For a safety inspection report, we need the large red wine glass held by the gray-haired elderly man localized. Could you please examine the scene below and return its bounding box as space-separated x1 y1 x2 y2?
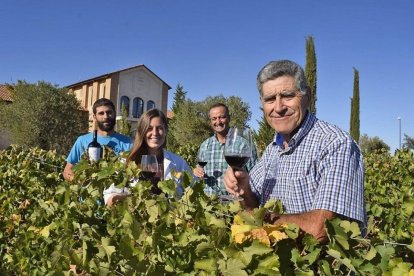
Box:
222 127 252 201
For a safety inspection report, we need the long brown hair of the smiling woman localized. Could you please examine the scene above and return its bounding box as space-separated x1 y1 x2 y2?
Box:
127 108 168 163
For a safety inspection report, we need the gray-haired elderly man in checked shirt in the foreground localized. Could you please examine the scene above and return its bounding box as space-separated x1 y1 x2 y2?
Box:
224 60 366 239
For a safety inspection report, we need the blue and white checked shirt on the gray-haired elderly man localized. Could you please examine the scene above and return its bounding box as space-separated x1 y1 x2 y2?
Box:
250 112 366 226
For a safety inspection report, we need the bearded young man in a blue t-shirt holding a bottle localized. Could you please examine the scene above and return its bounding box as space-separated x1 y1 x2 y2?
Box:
63 98 132 181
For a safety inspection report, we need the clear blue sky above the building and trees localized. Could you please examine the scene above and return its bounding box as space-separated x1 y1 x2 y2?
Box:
0 0 414 150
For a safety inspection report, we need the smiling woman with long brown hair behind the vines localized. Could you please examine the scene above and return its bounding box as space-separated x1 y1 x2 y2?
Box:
103 109 191 206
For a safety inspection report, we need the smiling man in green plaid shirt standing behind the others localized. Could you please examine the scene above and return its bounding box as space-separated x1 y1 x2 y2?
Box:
193 103 257 196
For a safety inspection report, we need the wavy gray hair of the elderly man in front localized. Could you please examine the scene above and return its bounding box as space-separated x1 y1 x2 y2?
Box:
257 60 308 95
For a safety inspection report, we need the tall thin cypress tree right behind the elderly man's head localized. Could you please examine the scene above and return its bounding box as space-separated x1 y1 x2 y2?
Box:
305 36 317 114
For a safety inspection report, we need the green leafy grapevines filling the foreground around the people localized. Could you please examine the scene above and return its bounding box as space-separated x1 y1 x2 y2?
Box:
0 146 414 276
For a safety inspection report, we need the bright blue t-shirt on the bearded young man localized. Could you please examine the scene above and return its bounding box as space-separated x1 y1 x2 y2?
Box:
66 132 132 165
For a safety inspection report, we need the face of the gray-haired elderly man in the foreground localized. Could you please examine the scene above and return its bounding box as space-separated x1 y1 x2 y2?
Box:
261 76 309 141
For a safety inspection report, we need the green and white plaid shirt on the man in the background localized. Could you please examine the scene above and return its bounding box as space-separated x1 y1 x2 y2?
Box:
200 135 257 195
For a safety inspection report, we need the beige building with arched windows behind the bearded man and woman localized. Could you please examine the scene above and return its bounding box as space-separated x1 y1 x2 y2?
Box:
66 65 171 134
